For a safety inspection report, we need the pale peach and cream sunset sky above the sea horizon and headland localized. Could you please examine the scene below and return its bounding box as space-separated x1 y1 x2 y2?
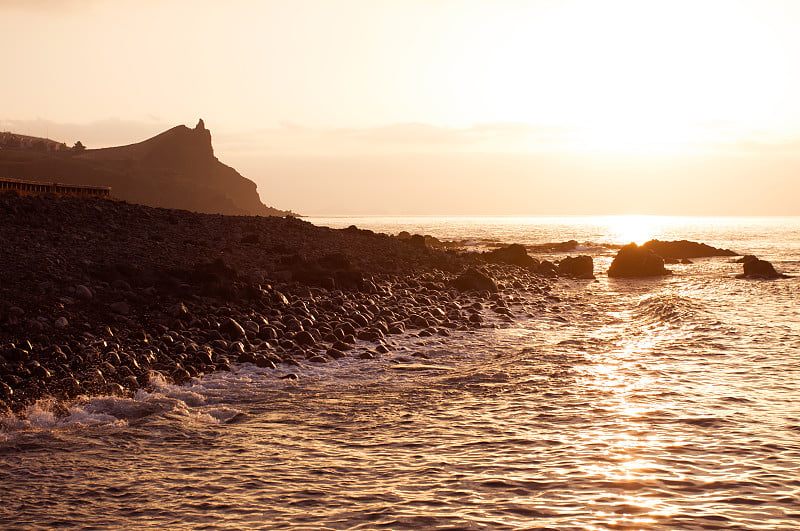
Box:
0 0 800 215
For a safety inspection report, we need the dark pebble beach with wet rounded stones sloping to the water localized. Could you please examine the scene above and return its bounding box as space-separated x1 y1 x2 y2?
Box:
0 195 564 416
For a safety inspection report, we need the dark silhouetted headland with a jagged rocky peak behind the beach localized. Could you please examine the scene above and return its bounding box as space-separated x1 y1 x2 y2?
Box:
0 120 292 216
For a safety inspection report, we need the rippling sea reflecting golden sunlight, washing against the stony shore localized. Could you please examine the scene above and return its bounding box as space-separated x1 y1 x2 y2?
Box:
0 216 800 530
